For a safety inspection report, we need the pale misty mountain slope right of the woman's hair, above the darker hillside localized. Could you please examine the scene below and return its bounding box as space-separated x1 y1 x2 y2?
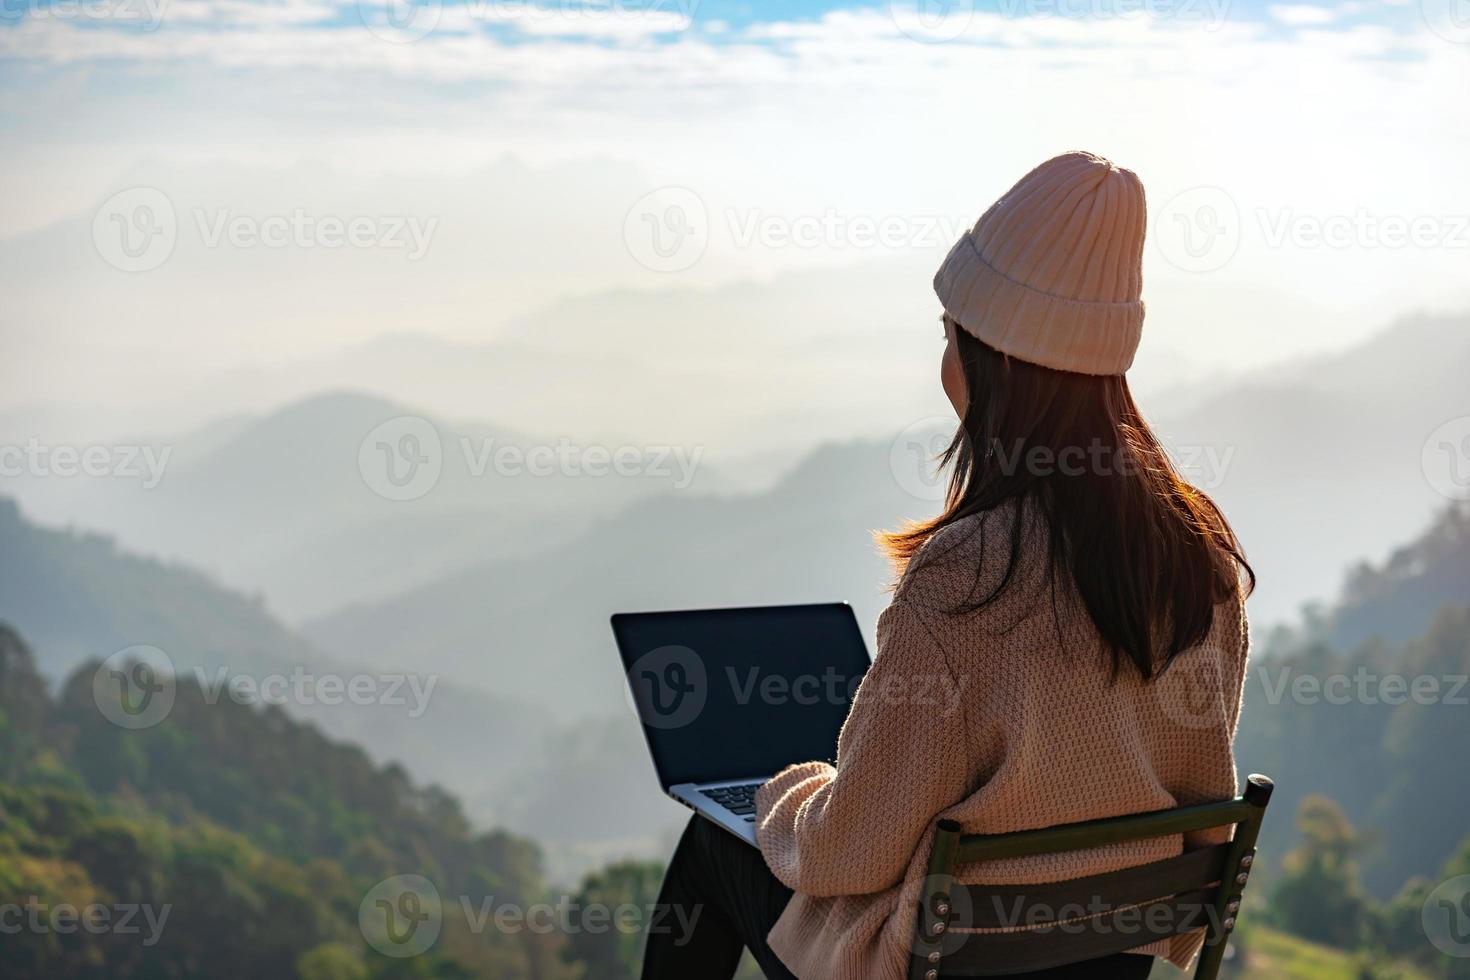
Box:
1145 316 1470 624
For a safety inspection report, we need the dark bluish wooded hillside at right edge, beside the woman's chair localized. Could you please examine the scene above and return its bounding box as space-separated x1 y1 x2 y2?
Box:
1236 504 1470 896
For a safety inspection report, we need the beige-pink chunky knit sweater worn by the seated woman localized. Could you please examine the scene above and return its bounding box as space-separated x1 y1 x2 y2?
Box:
756 505 1247 980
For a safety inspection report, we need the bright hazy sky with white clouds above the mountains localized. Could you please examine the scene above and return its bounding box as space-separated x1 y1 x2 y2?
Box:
0 0 1470 437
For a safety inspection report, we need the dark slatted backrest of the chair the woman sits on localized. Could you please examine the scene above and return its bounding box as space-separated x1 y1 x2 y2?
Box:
908 776 1273 980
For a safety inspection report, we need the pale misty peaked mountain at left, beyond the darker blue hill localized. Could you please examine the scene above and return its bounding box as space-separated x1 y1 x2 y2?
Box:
6 392 711 617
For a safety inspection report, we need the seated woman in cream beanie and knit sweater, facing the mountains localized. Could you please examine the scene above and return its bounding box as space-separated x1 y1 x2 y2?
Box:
644 153 1254 980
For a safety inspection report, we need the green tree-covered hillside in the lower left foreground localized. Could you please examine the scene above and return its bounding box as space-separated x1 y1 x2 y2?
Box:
0 626 616 980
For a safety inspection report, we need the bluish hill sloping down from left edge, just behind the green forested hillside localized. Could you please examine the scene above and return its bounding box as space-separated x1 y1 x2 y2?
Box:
0 498 542 820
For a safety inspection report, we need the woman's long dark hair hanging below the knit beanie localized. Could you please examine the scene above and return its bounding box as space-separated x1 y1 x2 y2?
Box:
881 319 1255 679
